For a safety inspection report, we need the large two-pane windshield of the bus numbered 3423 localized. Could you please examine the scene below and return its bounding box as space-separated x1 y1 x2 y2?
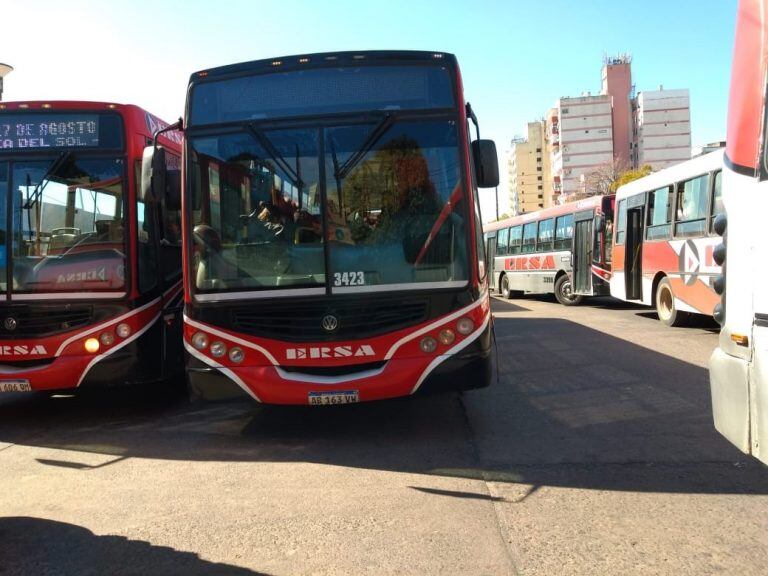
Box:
190 115 469 293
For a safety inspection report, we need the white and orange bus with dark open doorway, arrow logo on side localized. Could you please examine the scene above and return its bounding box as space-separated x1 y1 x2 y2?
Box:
611 150 723 326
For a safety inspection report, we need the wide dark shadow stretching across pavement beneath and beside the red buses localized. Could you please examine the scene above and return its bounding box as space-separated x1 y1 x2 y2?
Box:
0 304 768 497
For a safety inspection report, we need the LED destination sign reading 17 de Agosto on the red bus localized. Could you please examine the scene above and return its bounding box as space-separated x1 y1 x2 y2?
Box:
0 113 101 151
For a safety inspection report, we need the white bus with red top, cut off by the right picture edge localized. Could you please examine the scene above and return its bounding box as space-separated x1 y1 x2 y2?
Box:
709 0 768 463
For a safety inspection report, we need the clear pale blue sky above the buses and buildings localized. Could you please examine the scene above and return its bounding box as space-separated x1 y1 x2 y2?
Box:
0 0 736 220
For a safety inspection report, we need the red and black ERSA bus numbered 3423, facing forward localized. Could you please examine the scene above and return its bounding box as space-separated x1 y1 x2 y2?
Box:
146 52 498 404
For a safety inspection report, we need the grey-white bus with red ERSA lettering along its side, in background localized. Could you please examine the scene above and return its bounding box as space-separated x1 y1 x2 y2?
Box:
485 195 614 306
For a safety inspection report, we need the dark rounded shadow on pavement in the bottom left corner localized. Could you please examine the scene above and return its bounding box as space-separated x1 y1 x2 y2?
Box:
0 517 259 576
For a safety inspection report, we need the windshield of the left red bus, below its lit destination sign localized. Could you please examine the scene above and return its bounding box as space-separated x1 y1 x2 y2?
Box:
0 153 125 294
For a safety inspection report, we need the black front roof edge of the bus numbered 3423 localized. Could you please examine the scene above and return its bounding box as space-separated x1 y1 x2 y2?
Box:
190 50 456 82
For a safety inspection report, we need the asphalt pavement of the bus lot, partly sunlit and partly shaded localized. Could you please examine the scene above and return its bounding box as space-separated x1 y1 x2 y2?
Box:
0 297 768 576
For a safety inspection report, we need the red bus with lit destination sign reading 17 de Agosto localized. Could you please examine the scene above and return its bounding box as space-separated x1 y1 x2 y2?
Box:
0 102 183 391
